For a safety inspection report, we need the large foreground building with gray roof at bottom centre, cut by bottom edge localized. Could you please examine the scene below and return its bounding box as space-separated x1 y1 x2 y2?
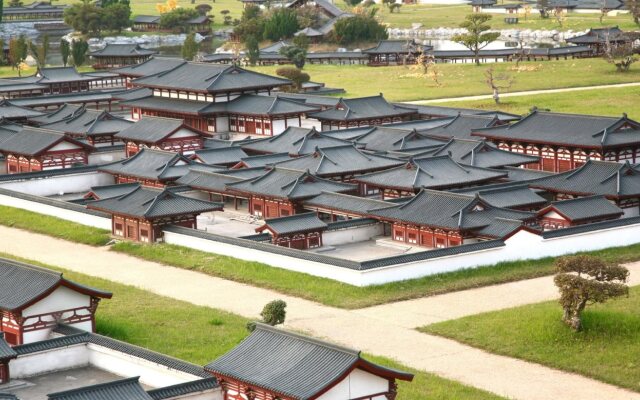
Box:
204 323 413 400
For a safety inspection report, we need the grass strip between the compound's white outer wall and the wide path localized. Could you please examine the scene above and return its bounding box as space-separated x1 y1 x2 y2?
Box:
6 207 640 309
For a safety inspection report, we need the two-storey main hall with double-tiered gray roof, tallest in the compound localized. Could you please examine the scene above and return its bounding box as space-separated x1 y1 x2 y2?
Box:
121 61 319 136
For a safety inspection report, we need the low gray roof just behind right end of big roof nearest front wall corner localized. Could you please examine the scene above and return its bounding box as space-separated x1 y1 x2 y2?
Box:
455 185 547 208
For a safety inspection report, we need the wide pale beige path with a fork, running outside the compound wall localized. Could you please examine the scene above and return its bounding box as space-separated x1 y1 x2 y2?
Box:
0 227 640 400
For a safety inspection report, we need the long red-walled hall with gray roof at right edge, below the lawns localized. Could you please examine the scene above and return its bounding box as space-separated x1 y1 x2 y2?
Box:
473 111 640 172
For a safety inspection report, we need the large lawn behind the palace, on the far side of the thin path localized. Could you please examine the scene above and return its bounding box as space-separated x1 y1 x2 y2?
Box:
249 58 640 101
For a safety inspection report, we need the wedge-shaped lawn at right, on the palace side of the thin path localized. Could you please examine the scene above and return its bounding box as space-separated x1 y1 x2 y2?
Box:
440 86 640 115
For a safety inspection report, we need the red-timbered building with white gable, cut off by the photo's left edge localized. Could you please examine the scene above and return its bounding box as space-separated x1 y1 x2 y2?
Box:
0 259 111 346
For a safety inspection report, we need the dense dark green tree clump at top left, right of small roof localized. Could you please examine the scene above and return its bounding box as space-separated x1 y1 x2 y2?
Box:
64 0 131 35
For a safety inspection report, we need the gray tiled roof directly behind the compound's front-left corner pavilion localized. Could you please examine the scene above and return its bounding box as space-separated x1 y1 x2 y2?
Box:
99 148 193 181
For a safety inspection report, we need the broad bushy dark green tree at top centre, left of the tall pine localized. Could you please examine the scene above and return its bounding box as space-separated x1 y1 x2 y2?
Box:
332 7 389 45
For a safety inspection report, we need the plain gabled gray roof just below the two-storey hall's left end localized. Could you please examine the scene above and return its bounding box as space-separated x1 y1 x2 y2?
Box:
114 116 204 143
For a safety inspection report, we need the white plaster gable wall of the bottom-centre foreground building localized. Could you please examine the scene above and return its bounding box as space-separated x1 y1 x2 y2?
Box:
318 369 389 400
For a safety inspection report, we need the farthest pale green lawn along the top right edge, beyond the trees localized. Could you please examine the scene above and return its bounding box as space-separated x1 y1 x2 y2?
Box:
356 2 637 31
